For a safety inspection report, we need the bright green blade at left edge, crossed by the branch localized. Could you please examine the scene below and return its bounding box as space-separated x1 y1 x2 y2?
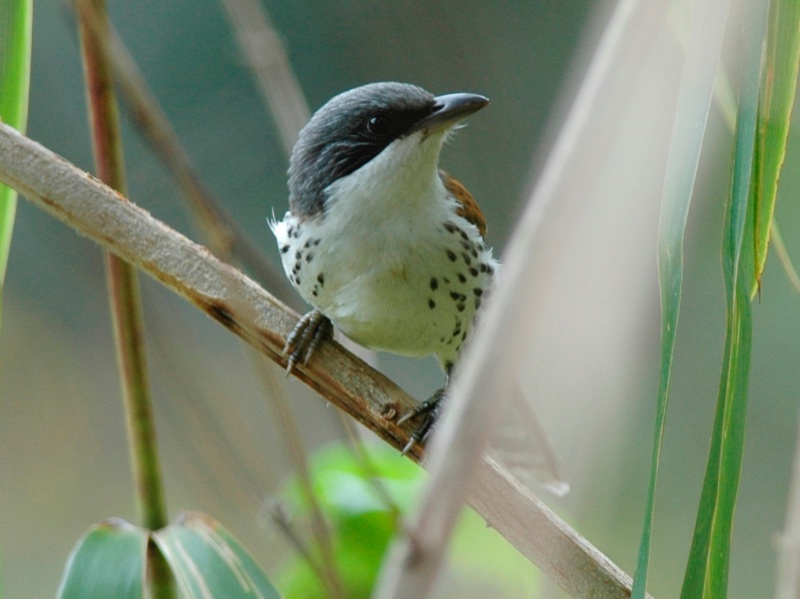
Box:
0 0 33 322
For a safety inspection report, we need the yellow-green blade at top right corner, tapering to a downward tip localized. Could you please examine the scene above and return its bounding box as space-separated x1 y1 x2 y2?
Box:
747 0 800 296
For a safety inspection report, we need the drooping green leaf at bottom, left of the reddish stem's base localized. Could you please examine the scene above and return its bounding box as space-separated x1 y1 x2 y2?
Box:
58 518 148 599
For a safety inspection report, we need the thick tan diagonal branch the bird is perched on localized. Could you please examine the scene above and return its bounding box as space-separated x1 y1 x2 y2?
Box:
0 123 631 598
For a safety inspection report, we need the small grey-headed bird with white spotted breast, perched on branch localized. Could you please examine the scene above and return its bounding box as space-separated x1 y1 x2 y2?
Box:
270 82 498 451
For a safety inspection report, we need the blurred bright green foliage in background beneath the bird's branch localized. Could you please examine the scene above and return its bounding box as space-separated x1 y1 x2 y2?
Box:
277 445 537 599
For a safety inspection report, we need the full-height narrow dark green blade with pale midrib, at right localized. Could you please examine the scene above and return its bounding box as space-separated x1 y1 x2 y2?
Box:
681 2 767 599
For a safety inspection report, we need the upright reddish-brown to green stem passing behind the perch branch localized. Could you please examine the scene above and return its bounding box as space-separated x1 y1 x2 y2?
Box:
77 0 175 598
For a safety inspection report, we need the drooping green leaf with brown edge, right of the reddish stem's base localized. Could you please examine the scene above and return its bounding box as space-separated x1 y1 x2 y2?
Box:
153 512 280 599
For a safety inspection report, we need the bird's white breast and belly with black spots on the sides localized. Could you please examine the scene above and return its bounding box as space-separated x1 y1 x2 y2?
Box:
271 136 496 365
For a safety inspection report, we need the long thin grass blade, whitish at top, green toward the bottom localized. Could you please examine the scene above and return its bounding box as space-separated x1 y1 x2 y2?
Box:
631 0 730 599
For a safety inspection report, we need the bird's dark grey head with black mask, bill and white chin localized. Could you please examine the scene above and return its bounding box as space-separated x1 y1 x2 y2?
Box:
289 82 489 216
